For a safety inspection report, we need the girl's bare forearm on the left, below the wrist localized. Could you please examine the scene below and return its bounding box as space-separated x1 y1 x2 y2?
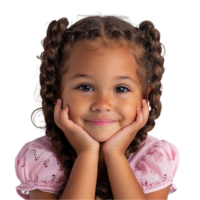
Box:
60 152 99 200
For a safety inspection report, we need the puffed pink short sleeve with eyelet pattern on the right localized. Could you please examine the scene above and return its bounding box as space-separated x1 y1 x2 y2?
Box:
133 139 179 195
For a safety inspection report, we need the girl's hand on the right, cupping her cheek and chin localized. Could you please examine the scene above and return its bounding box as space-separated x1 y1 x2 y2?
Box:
102 101 150 155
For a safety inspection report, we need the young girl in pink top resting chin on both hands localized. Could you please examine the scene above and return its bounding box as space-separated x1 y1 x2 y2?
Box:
14 11 179 200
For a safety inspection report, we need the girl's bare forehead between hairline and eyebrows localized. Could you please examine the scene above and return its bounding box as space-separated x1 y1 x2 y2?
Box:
68 43 137 73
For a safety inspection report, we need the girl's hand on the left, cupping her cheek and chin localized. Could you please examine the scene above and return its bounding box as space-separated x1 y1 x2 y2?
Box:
54 99 100 156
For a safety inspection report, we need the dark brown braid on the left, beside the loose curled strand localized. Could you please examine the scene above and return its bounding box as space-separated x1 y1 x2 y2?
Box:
31 17 76 198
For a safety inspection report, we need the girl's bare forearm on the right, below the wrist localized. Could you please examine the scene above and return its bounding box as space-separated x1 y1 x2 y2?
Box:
104 154 148 200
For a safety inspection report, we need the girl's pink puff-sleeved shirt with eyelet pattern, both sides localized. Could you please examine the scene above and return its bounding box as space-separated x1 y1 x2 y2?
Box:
14 134 179 200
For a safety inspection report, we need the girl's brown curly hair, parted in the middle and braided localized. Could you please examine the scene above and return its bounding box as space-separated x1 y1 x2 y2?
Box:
30 10 166 200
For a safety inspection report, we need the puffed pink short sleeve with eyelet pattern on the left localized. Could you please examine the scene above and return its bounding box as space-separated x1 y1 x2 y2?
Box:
14 136 67 200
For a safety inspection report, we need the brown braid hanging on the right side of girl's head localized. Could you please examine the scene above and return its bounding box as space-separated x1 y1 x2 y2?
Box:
125 20 166 159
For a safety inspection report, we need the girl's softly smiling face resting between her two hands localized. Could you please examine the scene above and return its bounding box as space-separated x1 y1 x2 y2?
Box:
58 42 151 144
